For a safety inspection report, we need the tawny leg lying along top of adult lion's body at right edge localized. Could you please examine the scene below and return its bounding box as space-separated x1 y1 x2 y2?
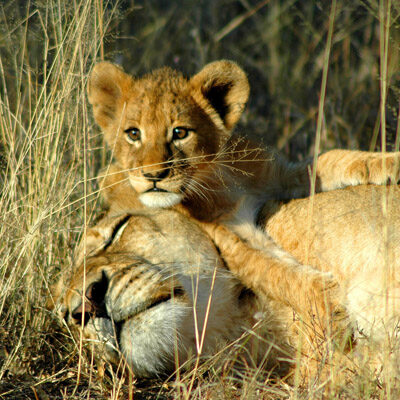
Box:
316 150 400 192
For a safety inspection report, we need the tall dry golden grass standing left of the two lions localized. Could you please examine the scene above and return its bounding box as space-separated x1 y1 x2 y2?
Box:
0 0 118 398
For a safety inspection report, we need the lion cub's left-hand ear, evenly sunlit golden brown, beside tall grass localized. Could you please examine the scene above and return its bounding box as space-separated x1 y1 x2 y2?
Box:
88 62 133 130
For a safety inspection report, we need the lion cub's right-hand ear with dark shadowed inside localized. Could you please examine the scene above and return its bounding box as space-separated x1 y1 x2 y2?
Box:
190 60 250 130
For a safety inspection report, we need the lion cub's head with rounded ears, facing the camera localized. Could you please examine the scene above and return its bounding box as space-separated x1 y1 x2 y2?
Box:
88 61 249 207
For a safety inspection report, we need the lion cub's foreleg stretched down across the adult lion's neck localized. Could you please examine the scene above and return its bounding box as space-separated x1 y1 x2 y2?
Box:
201 223 347 339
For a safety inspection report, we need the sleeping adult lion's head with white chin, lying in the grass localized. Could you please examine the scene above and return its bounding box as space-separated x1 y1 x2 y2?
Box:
57 210 288 377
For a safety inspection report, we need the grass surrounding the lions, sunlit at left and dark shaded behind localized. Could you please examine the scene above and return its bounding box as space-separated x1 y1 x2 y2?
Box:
0 0 400 398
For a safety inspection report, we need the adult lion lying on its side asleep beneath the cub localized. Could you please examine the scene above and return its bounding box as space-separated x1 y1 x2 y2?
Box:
60 186 400 376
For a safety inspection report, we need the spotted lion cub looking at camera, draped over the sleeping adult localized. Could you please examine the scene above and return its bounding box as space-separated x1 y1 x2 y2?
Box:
88 60 399 334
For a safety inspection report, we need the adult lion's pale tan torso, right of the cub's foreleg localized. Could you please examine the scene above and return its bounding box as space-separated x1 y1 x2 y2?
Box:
265 186 400 341
